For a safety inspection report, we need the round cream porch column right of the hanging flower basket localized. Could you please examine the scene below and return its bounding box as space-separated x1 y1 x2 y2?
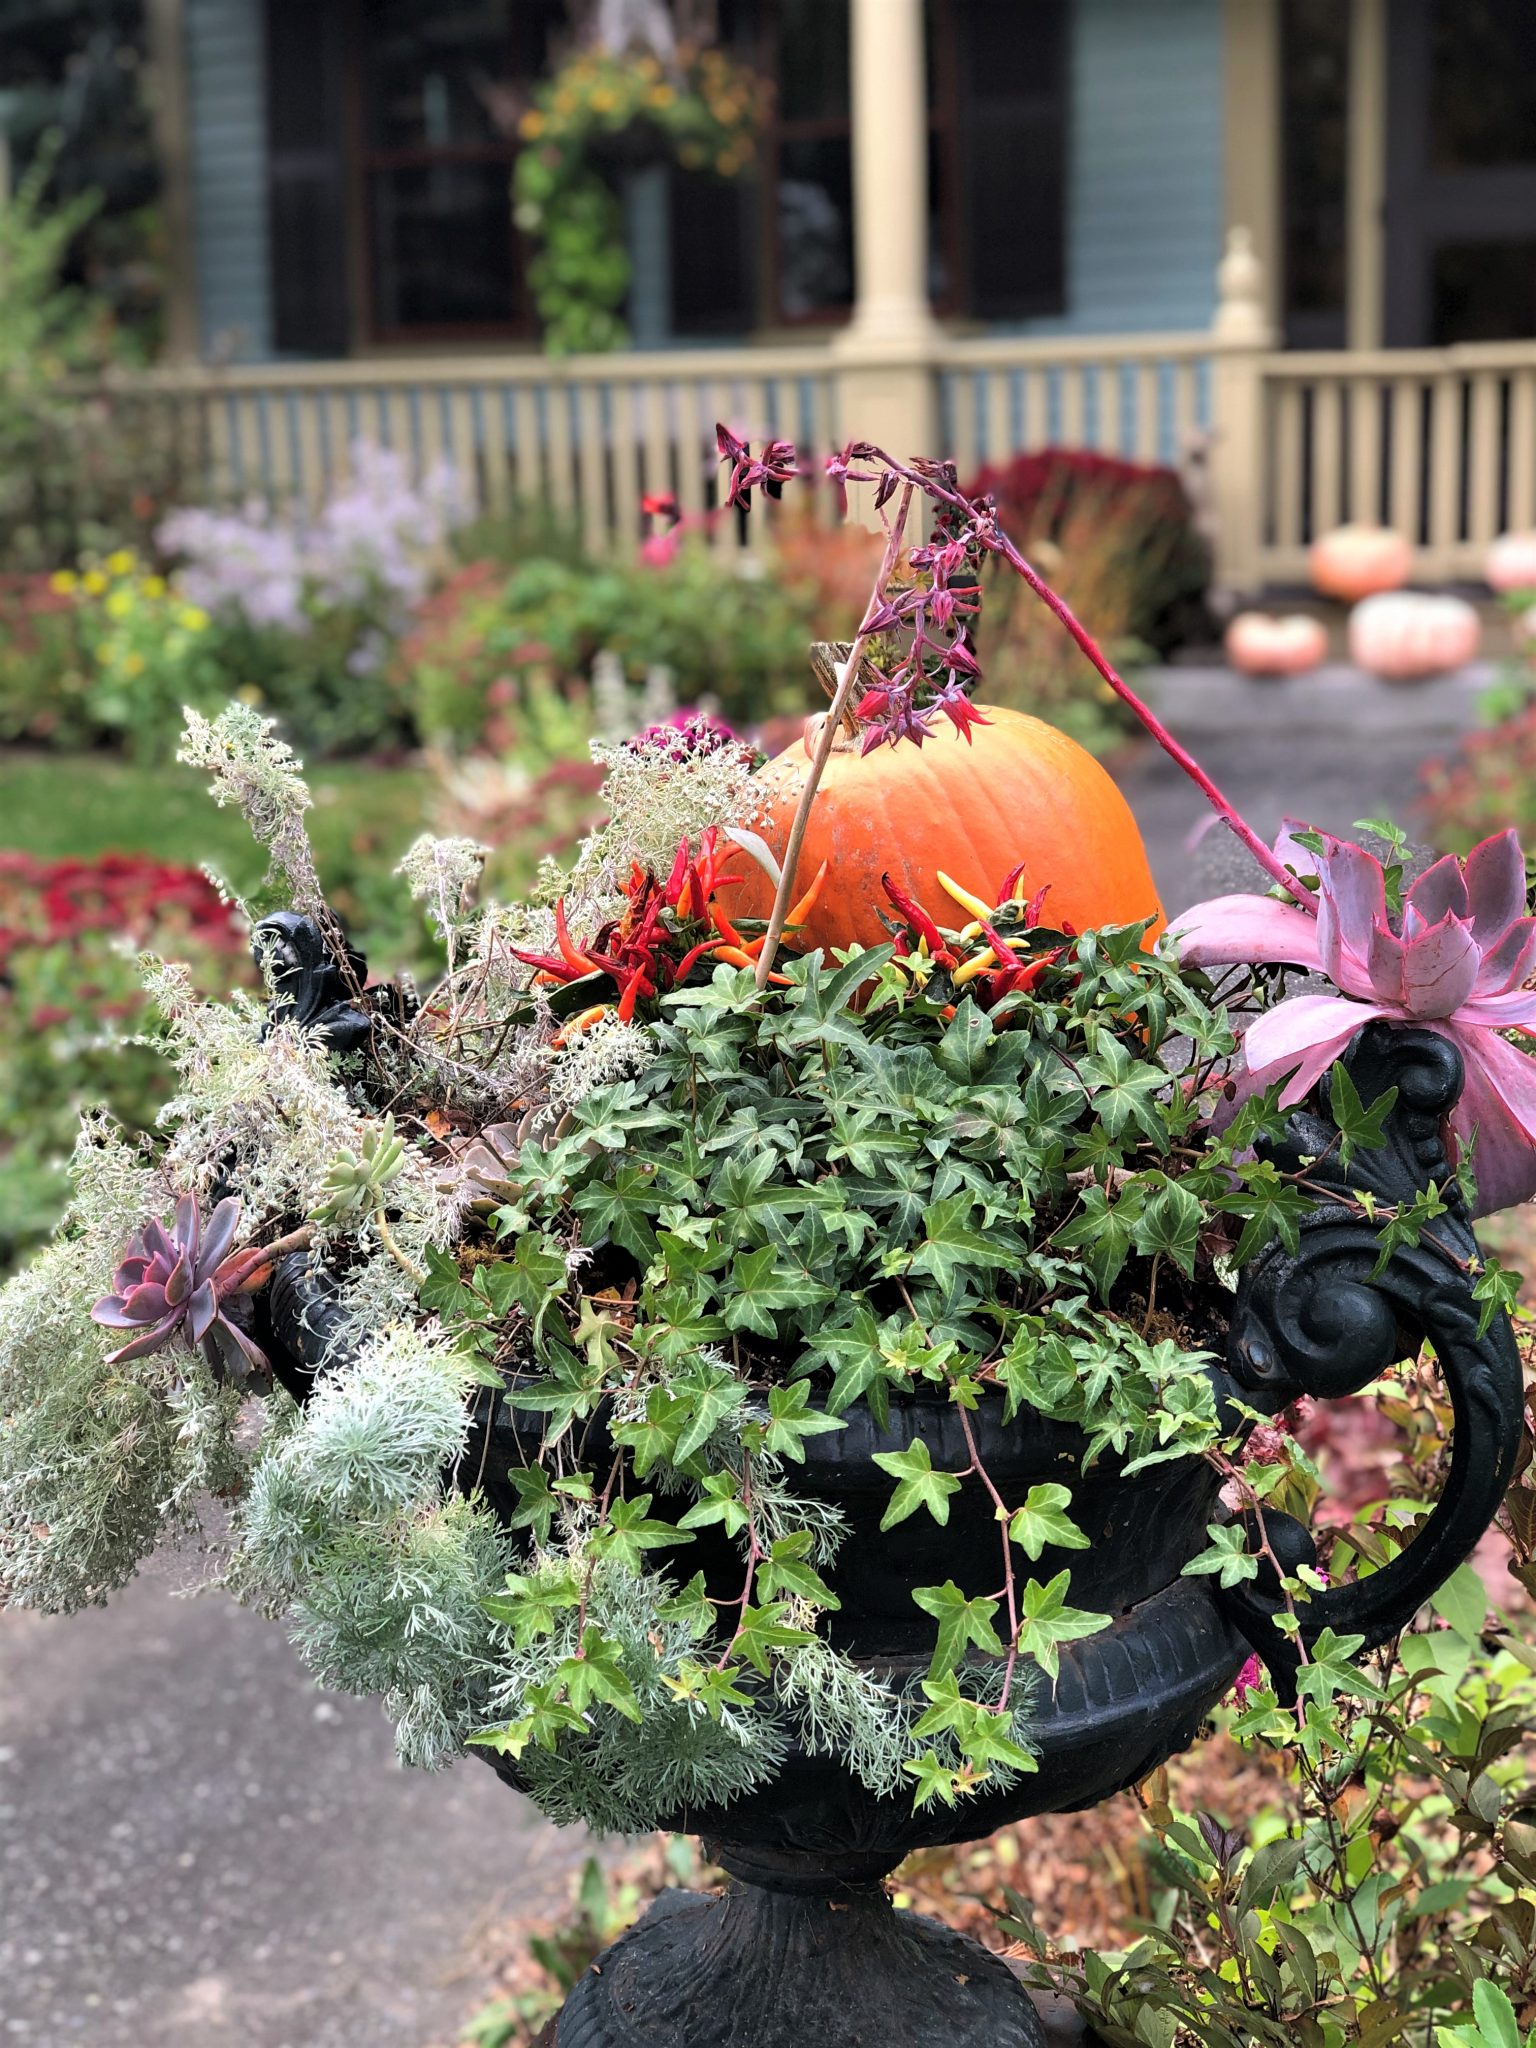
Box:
834 0 942 479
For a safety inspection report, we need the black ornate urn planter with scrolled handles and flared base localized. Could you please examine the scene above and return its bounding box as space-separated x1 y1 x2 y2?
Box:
266 932 1524 2048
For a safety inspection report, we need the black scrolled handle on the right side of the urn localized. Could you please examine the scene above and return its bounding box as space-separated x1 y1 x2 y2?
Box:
1219 1024 1524 1696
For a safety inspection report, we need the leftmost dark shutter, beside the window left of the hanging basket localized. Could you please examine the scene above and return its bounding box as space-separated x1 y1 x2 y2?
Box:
266 0 352 356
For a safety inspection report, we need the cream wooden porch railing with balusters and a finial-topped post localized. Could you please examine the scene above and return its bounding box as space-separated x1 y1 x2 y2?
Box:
93 231 1536 590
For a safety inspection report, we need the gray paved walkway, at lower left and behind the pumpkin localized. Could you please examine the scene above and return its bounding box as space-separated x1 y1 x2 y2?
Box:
0 670 1481 2048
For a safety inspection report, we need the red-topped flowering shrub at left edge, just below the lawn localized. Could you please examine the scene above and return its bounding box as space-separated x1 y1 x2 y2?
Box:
0 852 250 1268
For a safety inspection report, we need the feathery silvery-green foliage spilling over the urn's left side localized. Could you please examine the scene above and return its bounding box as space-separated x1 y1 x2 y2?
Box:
0 707 786 1825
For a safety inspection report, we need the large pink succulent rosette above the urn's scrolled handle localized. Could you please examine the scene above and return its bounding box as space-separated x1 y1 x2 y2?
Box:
1171 819 1536 1217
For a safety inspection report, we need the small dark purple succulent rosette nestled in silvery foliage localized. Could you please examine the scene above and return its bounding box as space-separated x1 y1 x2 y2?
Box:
90 1194 270 1378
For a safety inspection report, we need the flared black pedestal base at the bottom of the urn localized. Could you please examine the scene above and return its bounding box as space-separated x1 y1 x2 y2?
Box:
553 1880 1047 2048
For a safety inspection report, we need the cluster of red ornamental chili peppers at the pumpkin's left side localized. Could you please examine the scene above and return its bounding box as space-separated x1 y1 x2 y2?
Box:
512 825 827 1036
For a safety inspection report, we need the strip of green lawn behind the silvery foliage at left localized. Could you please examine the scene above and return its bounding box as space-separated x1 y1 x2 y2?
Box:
0 750 432 967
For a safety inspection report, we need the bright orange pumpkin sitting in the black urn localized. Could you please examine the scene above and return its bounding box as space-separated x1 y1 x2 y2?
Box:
721 705 1163 950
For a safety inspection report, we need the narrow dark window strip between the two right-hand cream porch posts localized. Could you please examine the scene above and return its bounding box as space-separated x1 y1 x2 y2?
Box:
1280 0 1350 348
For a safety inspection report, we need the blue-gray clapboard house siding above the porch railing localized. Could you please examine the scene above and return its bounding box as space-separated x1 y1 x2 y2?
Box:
186 0 1225 360
